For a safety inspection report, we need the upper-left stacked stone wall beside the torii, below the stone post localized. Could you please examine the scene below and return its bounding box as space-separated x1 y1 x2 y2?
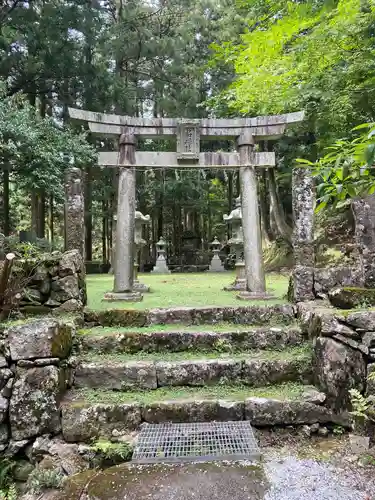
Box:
14 250 87 314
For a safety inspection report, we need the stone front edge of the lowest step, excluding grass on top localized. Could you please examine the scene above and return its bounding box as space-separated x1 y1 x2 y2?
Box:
62 397 350 442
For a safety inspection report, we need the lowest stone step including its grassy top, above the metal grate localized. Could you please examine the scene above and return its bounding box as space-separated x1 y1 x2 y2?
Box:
61 383 349 442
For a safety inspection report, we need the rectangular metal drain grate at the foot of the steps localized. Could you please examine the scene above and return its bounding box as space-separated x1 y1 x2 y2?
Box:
132 421 260 463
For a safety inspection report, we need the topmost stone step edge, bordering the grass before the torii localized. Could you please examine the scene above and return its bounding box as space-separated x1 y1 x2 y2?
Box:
84 304 296 327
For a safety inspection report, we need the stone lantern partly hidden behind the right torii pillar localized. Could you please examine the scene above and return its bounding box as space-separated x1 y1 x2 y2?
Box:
223 196 247 291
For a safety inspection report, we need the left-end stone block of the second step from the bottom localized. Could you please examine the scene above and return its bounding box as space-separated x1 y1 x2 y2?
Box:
74 361 157 391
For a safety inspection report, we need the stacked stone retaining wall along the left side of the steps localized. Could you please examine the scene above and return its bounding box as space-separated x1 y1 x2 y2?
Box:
0 318 75 455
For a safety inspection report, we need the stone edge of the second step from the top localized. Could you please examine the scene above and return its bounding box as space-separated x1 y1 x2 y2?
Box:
79 324 303 354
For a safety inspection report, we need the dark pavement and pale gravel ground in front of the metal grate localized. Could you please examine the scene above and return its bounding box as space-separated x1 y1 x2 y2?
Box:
54 438 375 500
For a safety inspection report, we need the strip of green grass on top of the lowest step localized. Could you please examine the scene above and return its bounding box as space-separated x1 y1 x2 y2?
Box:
63 382 311 406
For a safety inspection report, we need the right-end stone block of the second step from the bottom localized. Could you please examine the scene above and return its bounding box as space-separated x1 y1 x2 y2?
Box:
242 355 312 387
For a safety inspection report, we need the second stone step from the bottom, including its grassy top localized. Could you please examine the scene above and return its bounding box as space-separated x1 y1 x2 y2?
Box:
74 345 312 391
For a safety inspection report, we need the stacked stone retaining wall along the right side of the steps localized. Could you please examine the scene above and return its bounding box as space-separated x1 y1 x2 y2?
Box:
298 302 375 411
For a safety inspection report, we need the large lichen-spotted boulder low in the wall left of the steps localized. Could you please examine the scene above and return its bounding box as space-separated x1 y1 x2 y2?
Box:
9 366 62 441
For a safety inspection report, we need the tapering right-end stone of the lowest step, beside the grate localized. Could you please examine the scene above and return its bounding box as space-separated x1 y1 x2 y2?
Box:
245 398 348 427
